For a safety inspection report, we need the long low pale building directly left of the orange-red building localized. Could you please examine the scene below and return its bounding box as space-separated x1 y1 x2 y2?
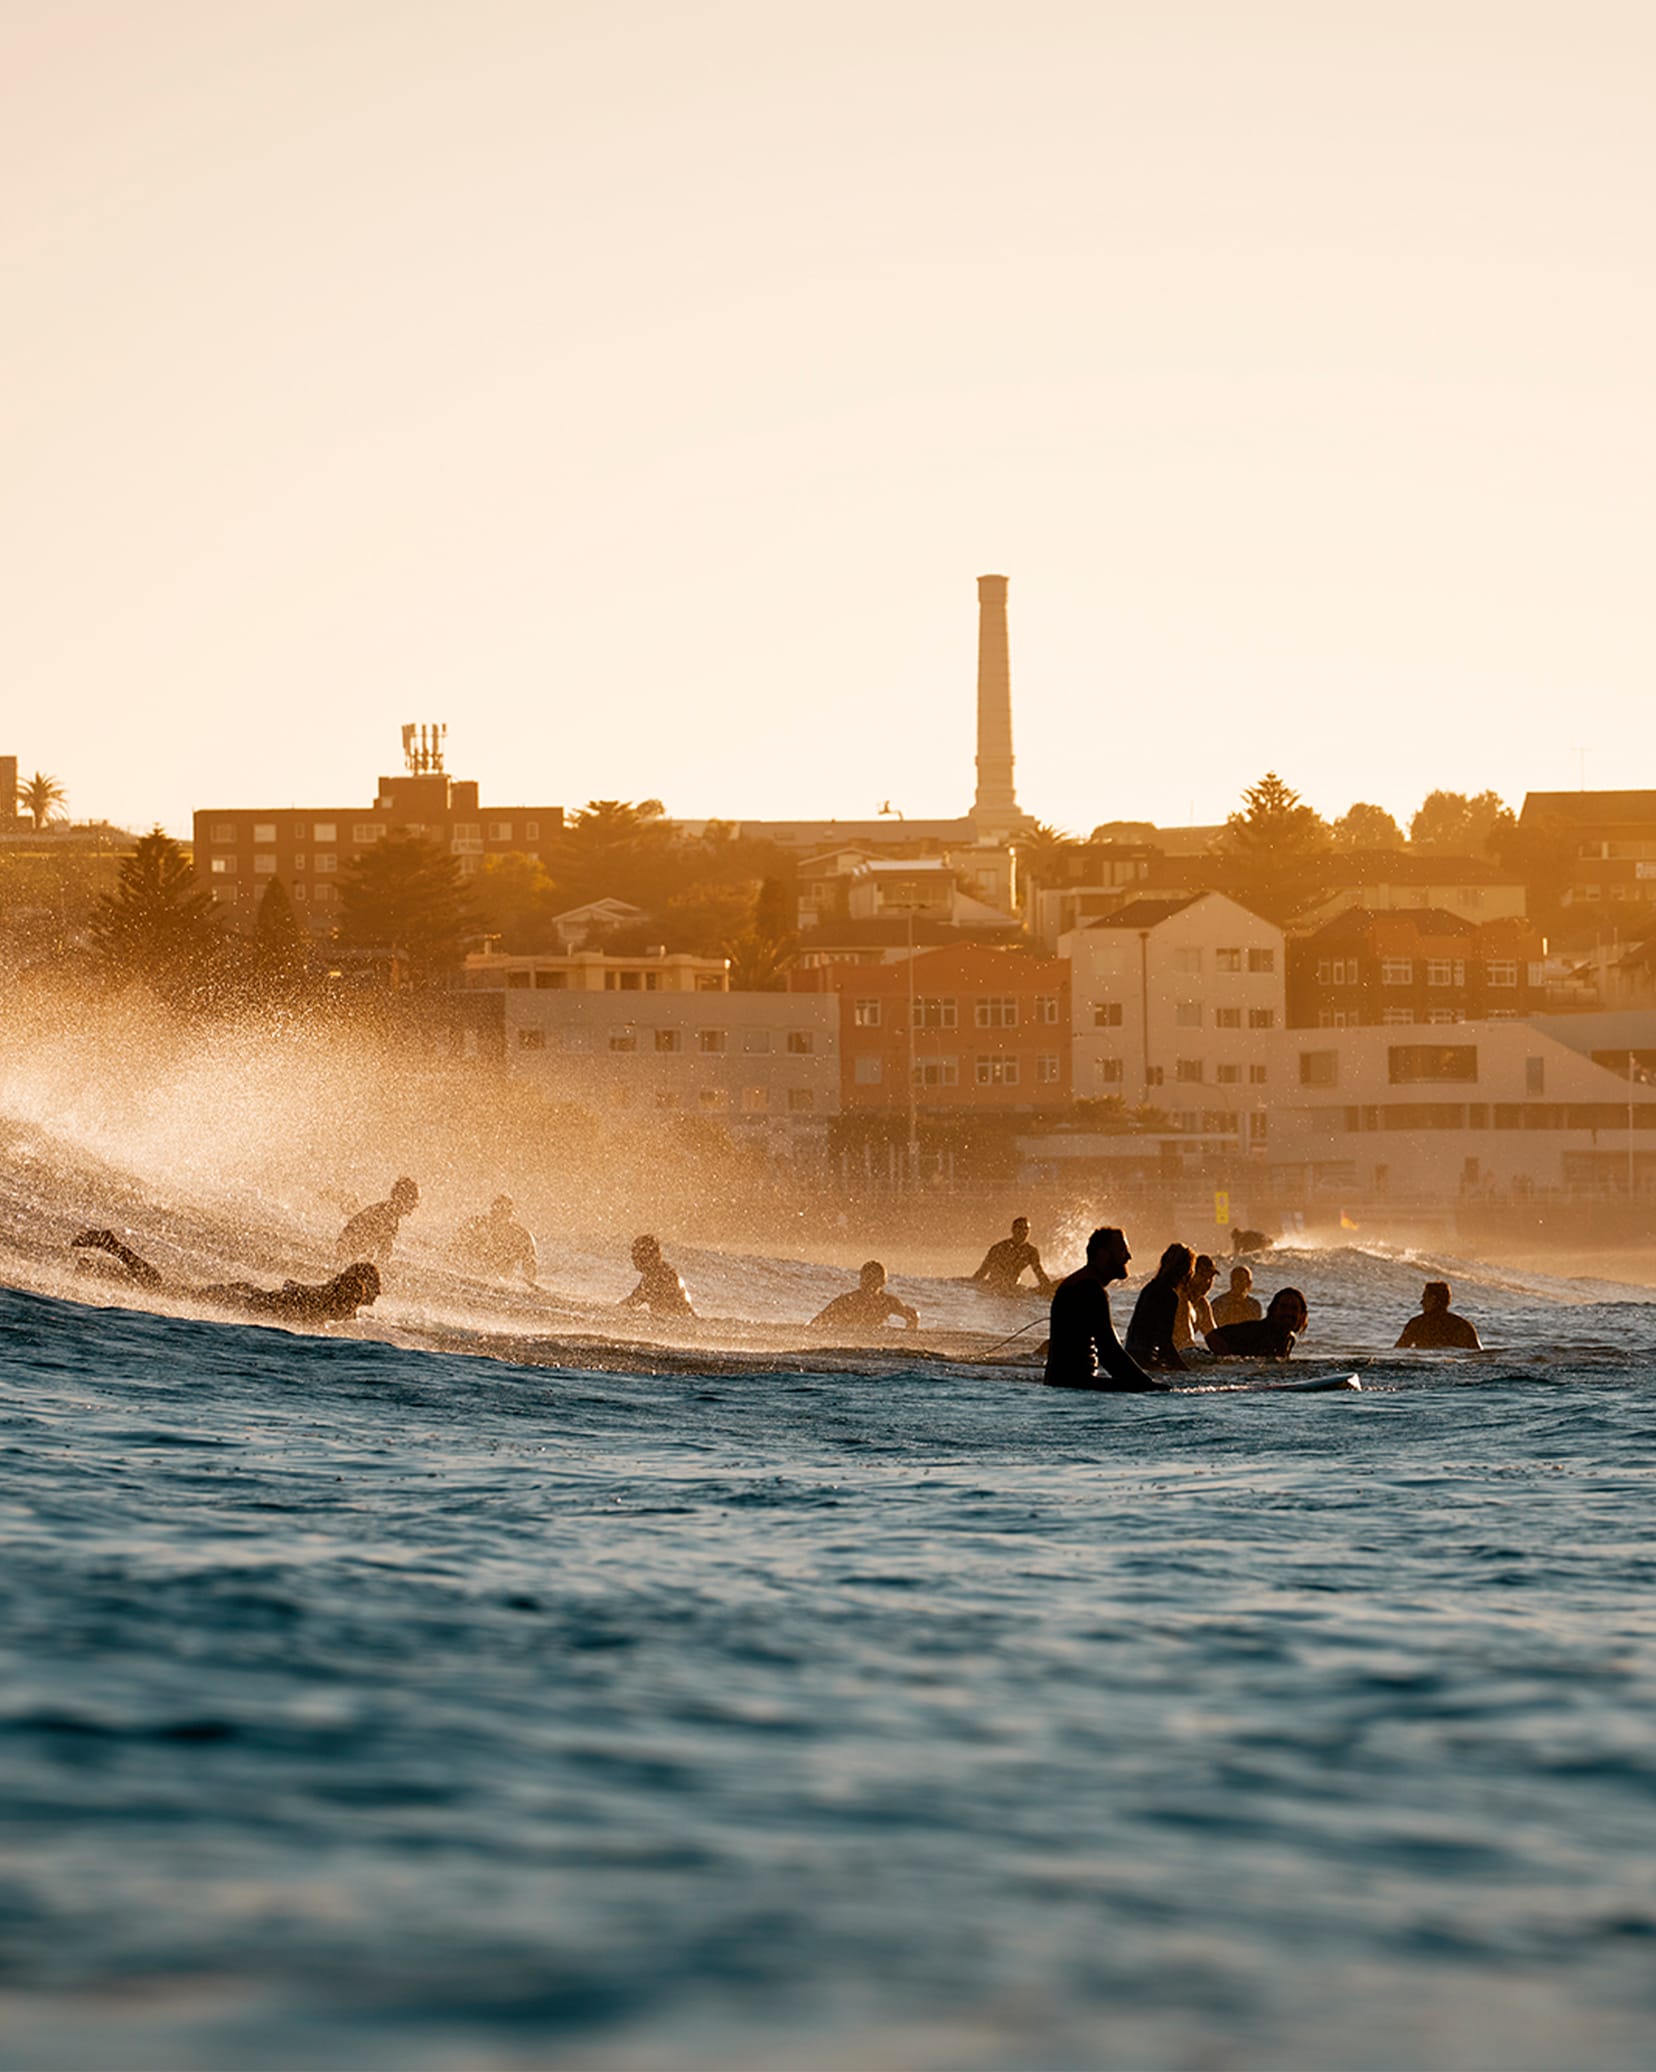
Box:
484 986 839 1158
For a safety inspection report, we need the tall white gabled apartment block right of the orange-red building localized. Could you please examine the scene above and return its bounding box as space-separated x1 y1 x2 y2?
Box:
1059 893 1287 1150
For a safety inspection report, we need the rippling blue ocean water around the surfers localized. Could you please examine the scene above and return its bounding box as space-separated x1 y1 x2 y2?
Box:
0 1193 1656 2068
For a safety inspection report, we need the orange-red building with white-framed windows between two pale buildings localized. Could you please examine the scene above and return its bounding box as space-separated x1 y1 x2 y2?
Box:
790 943 1072 1115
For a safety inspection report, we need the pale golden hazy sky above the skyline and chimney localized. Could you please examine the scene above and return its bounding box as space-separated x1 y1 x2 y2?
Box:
0 0 1656 831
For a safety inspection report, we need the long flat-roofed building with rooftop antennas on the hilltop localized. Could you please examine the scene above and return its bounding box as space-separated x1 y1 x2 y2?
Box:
195 729 564 934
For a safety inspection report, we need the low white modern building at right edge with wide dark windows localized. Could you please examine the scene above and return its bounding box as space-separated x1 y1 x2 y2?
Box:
1270 1015 1656 1204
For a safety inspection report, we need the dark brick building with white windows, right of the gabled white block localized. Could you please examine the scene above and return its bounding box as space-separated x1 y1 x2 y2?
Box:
1287 908 1548 1028
